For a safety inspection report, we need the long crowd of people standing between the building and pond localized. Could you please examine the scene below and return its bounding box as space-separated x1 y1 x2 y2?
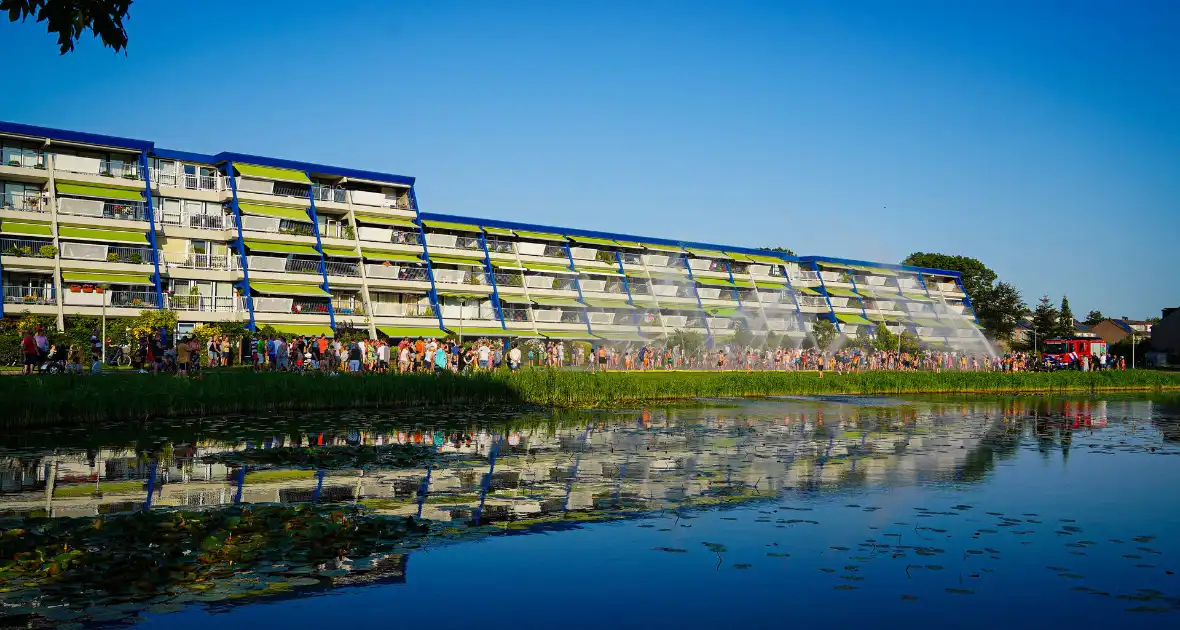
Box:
21 328 1127 375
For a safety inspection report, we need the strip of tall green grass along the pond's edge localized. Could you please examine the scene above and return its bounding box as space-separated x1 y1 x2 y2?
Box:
0 369 1180 428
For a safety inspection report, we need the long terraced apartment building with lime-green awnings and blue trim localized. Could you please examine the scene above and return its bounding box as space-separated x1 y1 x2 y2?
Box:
0 123 982 348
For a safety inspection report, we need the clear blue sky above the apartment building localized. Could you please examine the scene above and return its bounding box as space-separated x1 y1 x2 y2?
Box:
0 0 1180 317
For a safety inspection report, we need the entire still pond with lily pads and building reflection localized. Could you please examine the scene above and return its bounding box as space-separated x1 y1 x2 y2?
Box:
0 395 1180 630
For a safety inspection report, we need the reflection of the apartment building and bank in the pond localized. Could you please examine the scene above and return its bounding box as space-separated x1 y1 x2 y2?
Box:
0 396 1180 623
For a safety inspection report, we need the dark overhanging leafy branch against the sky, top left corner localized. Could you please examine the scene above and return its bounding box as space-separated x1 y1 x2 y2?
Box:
0 0 132 54
